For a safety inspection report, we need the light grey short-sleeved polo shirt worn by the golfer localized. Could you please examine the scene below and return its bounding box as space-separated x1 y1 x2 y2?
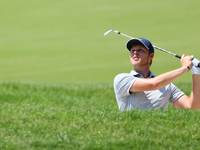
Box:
113 70 184 110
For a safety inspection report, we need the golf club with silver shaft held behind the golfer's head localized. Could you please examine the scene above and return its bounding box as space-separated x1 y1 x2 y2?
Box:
104 29 200 67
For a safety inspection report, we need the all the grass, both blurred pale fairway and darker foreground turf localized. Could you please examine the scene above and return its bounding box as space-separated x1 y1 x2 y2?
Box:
0 0 200 150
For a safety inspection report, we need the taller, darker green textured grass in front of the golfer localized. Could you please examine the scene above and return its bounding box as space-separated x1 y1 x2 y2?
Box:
0 83 200 150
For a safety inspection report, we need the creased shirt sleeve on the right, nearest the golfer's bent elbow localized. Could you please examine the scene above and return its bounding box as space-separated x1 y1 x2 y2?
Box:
169 83 185 105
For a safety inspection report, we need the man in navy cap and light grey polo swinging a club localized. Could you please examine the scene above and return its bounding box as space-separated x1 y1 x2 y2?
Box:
114 38 200 110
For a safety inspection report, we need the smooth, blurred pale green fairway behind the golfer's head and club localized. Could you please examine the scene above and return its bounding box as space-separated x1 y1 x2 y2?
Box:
0 0 200 83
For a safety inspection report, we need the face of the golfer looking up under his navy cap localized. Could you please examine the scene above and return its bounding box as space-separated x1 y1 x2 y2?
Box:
130 44 154 67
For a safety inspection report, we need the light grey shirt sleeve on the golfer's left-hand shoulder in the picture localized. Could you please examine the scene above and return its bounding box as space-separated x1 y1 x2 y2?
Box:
113 73 137 99
